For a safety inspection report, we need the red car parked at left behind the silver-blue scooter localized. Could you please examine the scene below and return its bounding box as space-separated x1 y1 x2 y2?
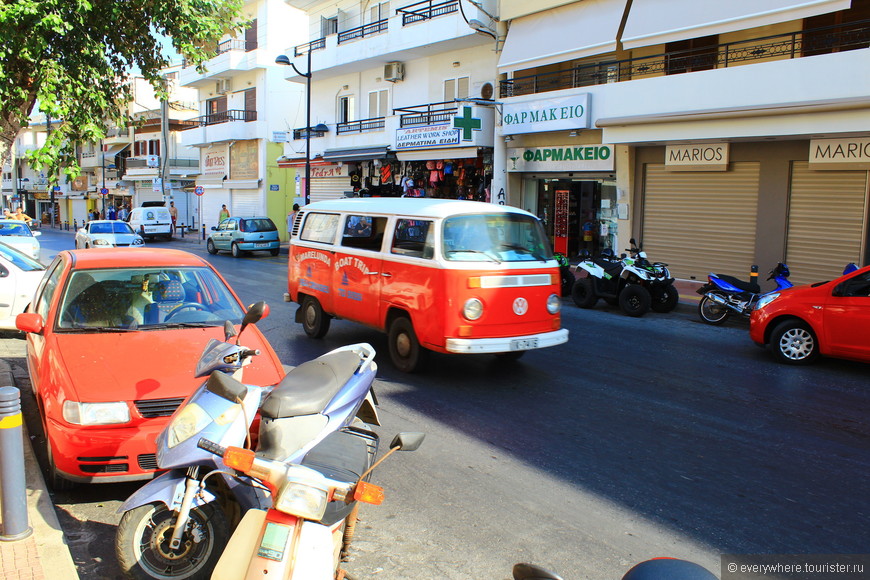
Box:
16 248 284 488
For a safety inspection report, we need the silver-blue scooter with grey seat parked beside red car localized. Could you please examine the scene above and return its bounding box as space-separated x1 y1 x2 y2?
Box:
115 302 379 580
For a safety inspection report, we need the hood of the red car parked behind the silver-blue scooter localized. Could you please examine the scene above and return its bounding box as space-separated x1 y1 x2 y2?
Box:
55 327 283 402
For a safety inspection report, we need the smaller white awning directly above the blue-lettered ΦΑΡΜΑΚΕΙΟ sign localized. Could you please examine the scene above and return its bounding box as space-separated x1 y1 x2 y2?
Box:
498 0 637 72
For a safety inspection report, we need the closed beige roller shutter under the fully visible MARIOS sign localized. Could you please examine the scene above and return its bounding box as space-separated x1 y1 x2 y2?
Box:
639 162 760 280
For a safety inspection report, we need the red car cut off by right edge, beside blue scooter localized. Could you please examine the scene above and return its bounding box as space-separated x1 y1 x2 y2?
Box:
749 266 870 364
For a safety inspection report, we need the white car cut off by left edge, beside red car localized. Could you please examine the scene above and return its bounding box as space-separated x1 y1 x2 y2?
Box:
0 243 45 330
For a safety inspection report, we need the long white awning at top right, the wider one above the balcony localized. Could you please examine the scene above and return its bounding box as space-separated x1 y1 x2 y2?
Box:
624 0 851 50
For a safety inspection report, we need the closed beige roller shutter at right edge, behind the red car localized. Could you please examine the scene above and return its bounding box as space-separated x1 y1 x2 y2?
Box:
786 161 867 284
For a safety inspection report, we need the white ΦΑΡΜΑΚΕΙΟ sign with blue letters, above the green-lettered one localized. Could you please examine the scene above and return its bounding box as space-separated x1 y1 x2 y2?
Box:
502 93 589 135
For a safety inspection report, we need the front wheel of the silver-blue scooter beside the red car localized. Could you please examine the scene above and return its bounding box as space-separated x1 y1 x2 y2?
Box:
115 503 230 580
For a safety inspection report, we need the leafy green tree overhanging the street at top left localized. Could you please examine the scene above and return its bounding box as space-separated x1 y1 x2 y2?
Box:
0 0 245 182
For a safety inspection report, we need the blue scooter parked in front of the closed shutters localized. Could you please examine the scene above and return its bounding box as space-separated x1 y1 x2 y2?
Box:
697 262 793 324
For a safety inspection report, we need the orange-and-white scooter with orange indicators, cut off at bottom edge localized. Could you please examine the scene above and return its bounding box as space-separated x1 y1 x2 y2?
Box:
199 433 424 580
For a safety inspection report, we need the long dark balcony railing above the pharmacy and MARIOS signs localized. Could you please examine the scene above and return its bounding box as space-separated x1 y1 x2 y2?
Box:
499 20 870 98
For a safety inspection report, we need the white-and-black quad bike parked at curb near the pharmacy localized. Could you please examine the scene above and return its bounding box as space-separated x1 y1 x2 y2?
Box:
571 238 680 316
